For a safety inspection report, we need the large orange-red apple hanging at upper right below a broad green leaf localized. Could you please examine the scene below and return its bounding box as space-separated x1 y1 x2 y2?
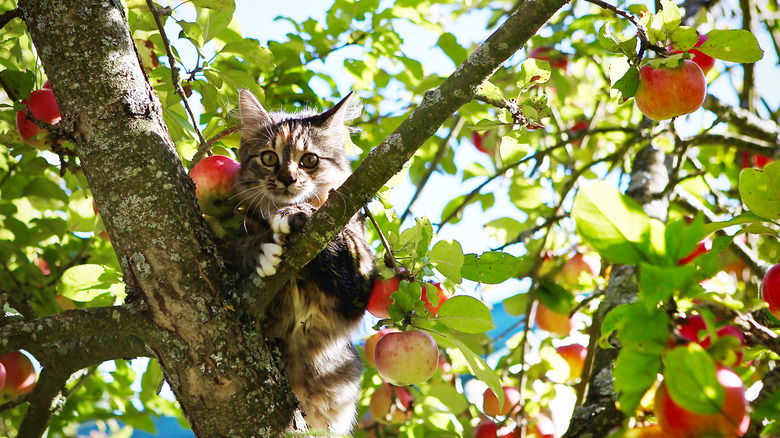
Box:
634 59 707 120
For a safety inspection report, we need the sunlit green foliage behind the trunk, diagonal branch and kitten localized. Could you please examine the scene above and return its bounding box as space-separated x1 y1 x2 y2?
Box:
0 0 780 436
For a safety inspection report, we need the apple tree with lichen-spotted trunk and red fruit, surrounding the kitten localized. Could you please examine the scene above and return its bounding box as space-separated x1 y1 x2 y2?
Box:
0 0 780 438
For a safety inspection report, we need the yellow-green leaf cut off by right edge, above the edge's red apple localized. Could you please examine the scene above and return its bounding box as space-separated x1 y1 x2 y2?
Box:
739 161 780 220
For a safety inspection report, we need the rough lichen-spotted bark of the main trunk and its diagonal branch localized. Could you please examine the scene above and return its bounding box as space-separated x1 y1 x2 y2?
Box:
7 0 566 437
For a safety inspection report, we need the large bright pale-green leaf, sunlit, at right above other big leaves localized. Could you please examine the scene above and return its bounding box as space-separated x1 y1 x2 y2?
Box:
571 181 650 265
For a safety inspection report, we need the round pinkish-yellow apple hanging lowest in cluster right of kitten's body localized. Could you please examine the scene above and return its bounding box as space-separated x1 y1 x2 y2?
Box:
374 330 439 386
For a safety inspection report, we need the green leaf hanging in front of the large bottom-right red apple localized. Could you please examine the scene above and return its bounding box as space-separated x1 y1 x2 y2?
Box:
664 342 726 414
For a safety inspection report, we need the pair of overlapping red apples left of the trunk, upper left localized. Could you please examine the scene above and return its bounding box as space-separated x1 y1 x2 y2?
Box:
16 81 62 150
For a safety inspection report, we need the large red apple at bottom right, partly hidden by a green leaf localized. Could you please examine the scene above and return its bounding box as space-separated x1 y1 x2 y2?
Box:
655 364 750 438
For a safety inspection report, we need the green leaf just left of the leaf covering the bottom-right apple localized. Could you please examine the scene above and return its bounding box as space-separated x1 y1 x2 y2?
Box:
612 347 661 415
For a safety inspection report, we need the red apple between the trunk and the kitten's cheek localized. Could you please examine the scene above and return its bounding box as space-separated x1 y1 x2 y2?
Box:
190 155 240 217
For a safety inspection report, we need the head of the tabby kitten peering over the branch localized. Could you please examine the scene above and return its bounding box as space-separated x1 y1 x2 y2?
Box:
236 90 360 218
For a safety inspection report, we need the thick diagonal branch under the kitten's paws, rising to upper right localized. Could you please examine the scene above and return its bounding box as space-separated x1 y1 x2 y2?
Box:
246 0 567 313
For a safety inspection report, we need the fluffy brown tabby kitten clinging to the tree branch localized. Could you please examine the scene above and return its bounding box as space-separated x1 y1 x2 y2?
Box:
235 90 375 435
